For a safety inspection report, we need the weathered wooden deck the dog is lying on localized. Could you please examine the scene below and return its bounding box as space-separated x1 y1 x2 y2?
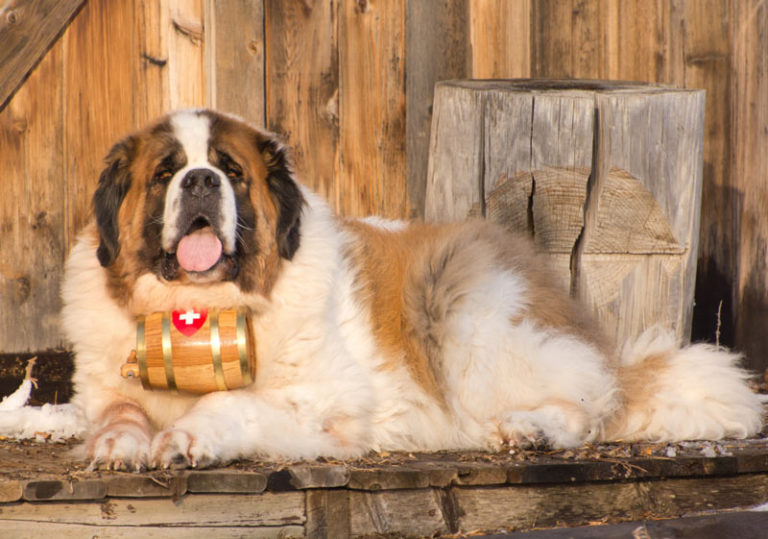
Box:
0 438 768 538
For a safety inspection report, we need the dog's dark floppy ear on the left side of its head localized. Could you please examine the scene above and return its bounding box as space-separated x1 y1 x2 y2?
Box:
93 138 135 267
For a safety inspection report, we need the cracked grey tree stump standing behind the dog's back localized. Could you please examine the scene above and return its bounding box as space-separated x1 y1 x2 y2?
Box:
425 80 704 342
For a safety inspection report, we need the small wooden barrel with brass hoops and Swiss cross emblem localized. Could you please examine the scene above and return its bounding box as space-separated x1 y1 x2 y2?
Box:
121 309 256 393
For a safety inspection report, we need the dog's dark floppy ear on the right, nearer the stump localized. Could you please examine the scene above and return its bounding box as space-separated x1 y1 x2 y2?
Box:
261 139 304 260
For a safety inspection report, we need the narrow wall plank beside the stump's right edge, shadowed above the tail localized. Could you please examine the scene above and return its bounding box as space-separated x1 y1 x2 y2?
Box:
684 0 740 346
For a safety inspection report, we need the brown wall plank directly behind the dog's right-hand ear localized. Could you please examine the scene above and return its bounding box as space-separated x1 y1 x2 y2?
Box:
264 0 339 202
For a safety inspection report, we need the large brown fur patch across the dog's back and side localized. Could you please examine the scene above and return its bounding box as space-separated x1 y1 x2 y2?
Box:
344 220 613 410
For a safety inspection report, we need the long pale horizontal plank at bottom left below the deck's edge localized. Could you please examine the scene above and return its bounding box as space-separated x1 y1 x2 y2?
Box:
0 492 306 528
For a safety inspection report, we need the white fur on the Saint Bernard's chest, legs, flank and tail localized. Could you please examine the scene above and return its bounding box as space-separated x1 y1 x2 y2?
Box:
63 115 762 467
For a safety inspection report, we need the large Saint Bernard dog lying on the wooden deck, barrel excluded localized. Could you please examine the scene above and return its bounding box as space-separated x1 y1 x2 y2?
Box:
62 110 763 470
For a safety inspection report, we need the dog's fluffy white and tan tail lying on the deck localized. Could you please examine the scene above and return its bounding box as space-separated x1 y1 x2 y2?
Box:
603 329 764 442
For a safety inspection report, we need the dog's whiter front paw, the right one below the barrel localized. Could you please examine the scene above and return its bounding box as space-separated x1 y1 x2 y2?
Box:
152 429 218 469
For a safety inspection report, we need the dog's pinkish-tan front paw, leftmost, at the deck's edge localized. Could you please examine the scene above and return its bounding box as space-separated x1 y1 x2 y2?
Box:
86 422 150 471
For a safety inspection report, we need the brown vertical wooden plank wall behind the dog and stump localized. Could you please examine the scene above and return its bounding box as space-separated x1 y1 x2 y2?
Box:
0 0 768 367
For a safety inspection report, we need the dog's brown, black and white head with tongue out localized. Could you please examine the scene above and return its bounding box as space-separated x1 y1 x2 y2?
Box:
93 110 303 304
